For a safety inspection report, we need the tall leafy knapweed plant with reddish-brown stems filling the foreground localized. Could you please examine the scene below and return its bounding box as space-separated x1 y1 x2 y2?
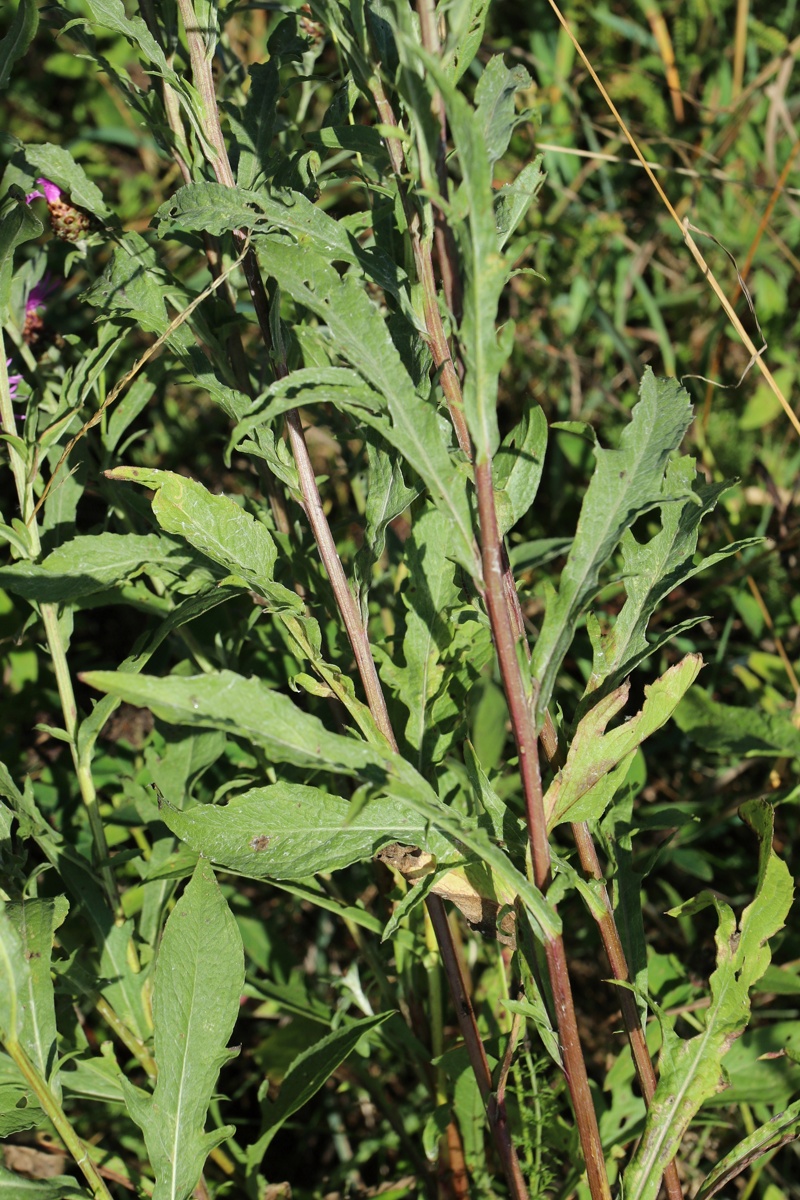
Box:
0 0 800 1200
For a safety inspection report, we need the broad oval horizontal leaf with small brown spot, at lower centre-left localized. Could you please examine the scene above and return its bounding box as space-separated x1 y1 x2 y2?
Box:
161 782 450 880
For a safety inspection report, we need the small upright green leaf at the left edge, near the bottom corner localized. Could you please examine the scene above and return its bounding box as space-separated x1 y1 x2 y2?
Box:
6 896 68 1103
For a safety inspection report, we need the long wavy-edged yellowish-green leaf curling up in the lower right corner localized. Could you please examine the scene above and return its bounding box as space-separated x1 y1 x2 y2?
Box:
624 800 793 1200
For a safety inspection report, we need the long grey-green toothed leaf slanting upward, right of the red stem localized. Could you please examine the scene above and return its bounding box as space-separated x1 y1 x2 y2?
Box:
531 368 692 725
